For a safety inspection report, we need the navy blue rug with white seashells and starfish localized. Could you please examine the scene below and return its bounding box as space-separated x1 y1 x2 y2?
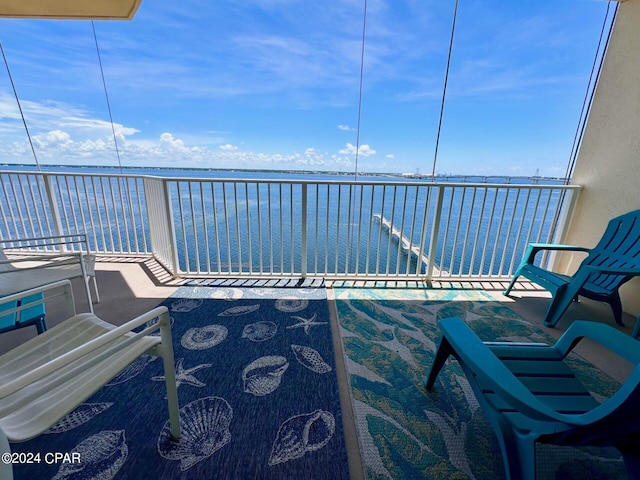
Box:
11 287 349 480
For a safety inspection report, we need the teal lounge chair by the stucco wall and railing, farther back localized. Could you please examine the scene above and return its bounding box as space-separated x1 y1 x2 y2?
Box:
504 210 640 327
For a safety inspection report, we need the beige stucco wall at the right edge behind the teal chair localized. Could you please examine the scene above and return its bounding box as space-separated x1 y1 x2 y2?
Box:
556 0 640 315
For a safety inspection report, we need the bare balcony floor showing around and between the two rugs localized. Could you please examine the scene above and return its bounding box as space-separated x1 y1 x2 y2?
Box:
0 253 635 479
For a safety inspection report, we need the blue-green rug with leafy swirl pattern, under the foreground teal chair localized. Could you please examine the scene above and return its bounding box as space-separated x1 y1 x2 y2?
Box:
332 285 626 480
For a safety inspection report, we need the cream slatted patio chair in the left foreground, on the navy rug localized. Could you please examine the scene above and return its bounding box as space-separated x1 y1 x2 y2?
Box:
0 280 180 478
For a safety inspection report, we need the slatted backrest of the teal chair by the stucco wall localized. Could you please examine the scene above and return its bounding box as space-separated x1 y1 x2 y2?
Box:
582 210 640 292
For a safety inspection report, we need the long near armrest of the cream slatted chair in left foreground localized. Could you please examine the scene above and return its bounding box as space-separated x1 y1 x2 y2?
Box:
0 306 171 398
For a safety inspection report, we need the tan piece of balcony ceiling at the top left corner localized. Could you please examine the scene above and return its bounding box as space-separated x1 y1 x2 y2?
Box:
0 0 142 20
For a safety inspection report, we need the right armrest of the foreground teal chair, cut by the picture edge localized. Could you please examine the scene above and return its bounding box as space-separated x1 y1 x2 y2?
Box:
553 320 640 365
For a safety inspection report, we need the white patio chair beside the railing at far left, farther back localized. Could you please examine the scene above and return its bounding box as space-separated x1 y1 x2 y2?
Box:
0 234 100 316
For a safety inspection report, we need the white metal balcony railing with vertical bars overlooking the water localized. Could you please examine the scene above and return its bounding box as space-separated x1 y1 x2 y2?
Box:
0 172 579 280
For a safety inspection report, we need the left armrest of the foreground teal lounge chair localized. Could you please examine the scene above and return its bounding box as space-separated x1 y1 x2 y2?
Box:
439 318 577 423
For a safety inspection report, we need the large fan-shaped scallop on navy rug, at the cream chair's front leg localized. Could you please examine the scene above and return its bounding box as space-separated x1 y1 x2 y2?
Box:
158 397 233 472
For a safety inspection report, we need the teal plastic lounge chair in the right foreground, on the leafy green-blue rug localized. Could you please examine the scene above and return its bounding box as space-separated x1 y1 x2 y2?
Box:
425 318 640 480
